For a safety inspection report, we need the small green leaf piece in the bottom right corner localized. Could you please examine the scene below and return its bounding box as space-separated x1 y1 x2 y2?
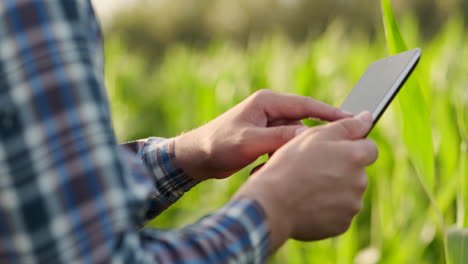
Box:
447 228 468 264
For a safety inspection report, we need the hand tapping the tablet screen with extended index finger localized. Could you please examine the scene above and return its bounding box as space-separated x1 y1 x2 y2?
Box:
175 90 350 181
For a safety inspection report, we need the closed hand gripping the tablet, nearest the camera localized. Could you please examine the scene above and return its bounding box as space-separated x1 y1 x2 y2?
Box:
235 112 378 250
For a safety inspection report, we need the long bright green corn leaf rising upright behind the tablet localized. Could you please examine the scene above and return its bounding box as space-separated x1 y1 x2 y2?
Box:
382 0 435 193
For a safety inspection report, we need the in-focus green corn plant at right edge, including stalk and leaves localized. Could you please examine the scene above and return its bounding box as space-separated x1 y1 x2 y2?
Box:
382 0 468 264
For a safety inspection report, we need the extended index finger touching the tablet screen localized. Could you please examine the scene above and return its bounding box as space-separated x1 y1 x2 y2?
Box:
253 90 353 122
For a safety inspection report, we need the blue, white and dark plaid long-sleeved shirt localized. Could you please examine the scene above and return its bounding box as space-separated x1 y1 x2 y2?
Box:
0 0 268 263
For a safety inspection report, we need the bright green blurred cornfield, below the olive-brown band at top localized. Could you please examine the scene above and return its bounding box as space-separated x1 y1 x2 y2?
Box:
101 0 468 264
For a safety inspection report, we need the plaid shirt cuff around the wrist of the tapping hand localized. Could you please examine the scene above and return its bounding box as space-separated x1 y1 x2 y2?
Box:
137 137 198 202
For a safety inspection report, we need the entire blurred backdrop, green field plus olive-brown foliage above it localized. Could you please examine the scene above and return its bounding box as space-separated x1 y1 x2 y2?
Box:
93 0 468 264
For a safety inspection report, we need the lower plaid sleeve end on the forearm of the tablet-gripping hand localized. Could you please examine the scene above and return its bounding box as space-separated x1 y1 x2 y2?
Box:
140 198 270 264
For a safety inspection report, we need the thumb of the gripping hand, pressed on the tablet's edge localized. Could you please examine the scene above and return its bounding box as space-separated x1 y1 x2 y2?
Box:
320 111 373 140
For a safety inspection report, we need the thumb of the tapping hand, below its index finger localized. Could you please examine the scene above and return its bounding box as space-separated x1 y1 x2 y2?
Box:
249 125 307 155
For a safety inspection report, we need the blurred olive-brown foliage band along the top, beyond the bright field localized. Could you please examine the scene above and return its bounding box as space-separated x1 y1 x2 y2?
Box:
105 0 468 60
